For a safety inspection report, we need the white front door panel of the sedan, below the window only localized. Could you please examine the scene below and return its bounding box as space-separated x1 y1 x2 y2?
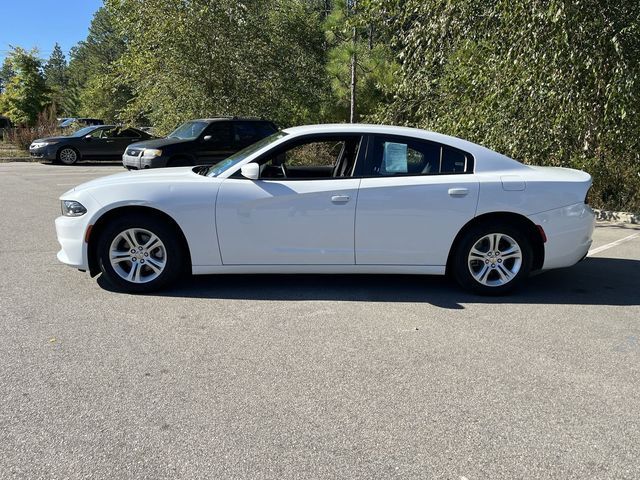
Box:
216 178 360 265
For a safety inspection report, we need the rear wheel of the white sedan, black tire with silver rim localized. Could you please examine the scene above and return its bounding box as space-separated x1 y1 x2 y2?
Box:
452 223 533 295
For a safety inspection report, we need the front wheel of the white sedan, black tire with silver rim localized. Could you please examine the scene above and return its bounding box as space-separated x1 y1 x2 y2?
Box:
97 214 186 293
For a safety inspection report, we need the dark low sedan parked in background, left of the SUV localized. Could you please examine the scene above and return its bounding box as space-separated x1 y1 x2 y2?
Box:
29 125 153 165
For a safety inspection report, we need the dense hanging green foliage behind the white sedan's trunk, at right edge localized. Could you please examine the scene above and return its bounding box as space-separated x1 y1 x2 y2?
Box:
378 0 640 209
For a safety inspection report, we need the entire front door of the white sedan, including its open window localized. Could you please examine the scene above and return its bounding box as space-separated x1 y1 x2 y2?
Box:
216 136 360 265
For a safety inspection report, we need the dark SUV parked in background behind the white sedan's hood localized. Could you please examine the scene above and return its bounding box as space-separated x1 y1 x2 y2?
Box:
122 117 278 169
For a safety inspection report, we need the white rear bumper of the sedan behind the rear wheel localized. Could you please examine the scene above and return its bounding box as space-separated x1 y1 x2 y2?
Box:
529 203 595 270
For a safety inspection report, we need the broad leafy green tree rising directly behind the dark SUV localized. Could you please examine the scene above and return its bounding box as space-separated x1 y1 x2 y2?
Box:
107 0 327 131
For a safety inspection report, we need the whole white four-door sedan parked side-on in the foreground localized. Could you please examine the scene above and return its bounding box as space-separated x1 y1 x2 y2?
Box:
56 124 594 294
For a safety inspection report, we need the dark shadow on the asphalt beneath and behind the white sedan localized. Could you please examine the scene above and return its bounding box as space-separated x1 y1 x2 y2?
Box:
98 257 640 309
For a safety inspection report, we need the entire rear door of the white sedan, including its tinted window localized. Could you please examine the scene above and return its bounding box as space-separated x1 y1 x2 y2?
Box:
355 135 479 266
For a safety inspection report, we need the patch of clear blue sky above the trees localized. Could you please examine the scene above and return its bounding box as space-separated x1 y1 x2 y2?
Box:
0 0 102 63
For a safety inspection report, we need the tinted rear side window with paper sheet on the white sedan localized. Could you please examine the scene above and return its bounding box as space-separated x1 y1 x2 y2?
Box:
368 136 469 176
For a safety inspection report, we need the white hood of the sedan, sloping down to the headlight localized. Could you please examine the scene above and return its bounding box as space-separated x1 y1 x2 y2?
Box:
63 167 211 197
